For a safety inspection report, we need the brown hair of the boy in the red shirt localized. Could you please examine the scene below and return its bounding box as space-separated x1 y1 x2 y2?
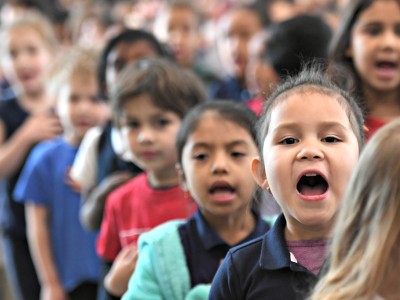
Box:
111 59 207 124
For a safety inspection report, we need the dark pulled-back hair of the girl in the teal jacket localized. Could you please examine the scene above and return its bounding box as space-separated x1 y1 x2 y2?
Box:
176 100 257 164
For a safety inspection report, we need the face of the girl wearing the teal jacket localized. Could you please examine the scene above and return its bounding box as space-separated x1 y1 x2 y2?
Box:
181 111 258 221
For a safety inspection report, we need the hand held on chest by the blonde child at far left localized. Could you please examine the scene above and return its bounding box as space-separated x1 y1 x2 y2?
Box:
21 113 63 144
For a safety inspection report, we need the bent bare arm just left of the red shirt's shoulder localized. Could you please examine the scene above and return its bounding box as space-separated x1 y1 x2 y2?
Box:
80 171 132 231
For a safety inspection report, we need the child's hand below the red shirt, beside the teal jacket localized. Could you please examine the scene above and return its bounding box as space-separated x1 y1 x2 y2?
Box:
104 244 138 296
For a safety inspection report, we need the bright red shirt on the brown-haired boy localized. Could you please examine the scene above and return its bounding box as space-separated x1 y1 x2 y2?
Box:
97 173 197 261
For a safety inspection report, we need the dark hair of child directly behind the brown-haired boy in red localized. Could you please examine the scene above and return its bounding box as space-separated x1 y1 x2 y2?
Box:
97 29 172 99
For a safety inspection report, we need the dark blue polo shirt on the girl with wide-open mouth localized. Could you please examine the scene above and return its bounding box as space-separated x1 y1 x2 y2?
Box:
209 215 317 300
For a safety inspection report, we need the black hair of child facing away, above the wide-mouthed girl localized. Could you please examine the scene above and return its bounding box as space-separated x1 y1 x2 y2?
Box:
264 15 332 79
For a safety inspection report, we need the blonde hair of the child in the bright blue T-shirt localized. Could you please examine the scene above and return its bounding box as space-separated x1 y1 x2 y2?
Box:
47 47 99 99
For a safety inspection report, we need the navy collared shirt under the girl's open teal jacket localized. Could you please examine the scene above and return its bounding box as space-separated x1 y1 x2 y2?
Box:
178 210 269 287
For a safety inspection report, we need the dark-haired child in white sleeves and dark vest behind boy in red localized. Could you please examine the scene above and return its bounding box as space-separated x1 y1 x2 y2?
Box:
71 30 168 230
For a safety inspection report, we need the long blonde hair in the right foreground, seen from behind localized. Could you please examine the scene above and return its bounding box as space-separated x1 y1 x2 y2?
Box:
310 119 400 300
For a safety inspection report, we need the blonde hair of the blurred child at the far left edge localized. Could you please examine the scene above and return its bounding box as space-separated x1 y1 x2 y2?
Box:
0 11 59 55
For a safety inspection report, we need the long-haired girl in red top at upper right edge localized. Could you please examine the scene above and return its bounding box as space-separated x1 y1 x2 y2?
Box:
331 0 400 140
